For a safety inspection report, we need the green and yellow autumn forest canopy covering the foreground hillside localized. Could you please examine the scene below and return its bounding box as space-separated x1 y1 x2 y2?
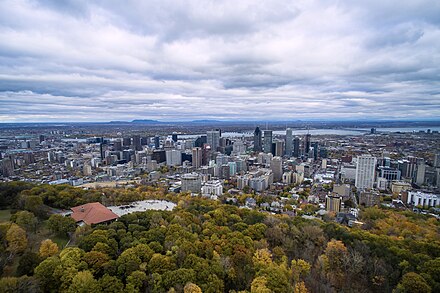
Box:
0 182 440 292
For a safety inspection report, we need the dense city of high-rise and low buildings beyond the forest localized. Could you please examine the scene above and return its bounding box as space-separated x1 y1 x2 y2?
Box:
0 127 440 221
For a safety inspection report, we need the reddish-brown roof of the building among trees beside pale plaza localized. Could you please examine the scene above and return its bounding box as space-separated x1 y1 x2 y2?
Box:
71 202 119 225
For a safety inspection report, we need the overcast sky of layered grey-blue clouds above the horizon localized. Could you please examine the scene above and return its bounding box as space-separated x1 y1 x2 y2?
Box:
0 0 440 122
